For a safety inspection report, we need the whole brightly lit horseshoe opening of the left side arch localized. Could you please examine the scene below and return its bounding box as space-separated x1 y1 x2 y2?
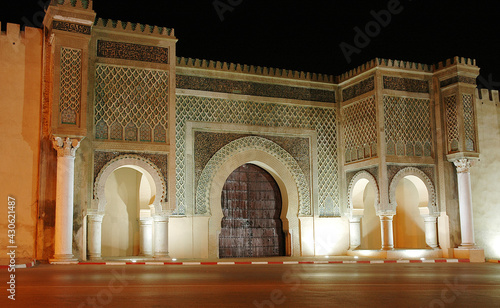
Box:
101 166 156 257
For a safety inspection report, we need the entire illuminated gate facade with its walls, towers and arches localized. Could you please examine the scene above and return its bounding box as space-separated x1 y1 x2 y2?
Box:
0 0 500 263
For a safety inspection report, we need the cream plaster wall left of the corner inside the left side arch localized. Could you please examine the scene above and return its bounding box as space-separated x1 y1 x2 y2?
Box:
102 168 141 257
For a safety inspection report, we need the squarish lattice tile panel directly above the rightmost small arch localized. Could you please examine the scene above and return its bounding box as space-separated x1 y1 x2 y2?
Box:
384 96 432 156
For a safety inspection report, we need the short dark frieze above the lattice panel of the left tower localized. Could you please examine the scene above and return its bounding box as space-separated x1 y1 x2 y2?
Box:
97 40 169 64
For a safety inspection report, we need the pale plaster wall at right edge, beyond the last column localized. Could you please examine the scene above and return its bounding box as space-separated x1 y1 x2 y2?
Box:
471 91 500 259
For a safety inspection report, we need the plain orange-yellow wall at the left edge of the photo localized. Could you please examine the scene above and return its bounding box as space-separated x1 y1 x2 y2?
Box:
0 24 42 264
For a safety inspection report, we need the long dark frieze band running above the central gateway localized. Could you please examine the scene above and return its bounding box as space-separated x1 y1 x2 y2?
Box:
176 75 335 103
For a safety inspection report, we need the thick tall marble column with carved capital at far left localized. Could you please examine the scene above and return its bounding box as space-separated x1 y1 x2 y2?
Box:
50 137 80 263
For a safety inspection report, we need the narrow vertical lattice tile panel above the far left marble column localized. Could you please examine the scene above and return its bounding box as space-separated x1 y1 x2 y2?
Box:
59 47 82 125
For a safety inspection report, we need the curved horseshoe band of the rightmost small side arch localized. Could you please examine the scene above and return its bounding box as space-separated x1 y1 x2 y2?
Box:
389 167 439 216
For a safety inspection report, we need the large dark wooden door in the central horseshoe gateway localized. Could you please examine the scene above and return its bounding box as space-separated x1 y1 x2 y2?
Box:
219 164 285 258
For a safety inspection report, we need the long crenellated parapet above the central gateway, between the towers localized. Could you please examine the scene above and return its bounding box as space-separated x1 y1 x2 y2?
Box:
177 57 335 83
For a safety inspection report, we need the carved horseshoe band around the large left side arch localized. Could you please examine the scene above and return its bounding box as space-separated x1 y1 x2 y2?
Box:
92 154 167 214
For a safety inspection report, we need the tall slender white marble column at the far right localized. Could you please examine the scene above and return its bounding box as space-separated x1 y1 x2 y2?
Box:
453 158 476 248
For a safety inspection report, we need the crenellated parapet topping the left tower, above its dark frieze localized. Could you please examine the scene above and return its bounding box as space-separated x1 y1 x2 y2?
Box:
94 18 175 39
